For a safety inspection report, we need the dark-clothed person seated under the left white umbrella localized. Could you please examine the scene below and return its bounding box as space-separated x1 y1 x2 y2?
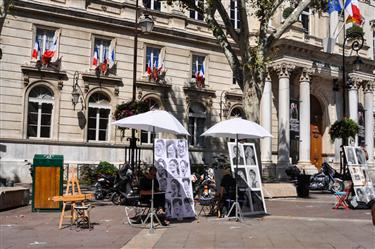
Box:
139 167 165 210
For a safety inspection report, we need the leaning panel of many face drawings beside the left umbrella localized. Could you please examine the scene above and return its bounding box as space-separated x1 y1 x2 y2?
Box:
155 139 195 219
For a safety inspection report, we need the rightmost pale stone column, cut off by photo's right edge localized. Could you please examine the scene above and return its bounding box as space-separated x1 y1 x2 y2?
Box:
363 82 375 167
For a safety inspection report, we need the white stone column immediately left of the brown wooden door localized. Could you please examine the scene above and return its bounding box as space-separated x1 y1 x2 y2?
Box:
298 69 317 175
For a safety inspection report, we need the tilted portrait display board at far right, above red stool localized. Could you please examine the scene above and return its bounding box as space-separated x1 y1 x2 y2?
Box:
344 146 375 203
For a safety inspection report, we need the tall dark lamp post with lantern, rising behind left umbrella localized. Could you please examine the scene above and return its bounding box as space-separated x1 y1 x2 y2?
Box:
129 0 154 171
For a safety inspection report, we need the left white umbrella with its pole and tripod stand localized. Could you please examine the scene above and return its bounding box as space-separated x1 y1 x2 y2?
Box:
112 110 189 232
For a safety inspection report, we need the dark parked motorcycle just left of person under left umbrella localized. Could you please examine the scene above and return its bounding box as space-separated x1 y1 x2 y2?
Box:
111 165 136 205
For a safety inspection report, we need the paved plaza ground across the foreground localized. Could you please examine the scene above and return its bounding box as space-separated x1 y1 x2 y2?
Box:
0 193 375 249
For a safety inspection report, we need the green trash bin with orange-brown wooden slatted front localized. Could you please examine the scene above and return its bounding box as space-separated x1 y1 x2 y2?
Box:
32 154 64 212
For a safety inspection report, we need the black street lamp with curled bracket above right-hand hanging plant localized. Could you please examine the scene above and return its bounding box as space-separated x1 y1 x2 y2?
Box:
342 27 365 116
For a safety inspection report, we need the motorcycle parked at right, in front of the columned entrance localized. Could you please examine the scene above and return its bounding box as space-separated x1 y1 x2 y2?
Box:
309 162 345 192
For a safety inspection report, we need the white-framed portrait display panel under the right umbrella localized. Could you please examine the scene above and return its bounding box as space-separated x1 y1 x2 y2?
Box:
228 142 267 215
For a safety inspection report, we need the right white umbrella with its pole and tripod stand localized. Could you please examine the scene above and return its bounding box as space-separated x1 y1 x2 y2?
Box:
201 118 272 221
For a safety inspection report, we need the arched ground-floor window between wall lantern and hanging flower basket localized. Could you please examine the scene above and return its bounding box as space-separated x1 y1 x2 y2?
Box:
87 92 111 141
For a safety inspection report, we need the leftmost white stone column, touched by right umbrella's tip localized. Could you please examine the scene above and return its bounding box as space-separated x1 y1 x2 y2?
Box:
260 74 272 171
